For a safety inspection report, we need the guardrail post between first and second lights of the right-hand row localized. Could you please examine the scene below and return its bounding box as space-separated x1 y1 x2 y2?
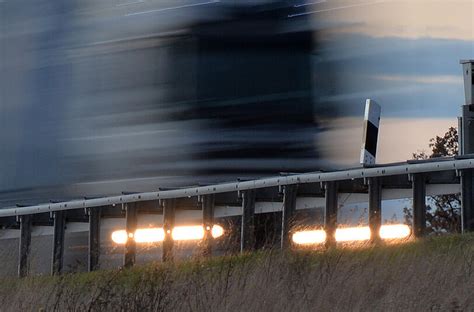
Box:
324 181 338 247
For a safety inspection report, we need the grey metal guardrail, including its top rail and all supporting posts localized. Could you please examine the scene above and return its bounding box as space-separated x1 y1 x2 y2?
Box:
0 155 474 277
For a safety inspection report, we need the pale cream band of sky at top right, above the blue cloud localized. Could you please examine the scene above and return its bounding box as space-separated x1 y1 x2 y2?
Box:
321 0 474 41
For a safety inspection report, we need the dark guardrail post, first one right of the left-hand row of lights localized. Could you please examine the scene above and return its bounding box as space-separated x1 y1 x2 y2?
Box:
240 190 257 252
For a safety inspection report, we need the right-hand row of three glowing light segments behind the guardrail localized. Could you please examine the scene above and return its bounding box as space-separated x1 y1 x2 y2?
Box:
292 224 411 245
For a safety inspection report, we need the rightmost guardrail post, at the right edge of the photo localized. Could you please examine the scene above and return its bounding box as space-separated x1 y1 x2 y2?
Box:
461 169 474 233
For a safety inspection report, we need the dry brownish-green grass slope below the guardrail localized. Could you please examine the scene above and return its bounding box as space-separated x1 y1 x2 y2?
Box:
0 235 474 311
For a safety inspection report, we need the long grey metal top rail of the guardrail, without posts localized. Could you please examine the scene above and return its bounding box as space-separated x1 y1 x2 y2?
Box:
0 156 468 217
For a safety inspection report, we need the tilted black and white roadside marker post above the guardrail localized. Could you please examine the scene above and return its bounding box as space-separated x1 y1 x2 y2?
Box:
360 99 381 167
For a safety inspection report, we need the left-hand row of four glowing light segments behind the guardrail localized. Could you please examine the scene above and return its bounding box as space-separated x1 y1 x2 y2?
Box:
112 224 224 245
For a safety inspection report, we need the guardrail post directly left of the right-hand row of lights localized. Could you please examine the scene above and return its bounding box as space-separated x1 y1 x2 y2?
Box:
281 184 298 249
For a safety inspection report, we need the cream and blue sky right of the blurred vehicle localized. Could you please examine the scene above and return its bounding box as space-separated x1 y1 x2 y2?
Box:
312 0 474 164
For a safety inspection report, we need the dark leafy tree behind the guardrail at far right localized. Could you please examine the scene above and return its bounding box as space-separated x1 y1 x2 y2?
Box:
410 127 461 234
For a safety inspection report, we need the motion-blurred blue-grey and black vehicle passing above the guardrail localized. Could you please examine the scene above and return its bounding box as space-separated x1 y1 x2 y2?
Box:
0 0 330 206
